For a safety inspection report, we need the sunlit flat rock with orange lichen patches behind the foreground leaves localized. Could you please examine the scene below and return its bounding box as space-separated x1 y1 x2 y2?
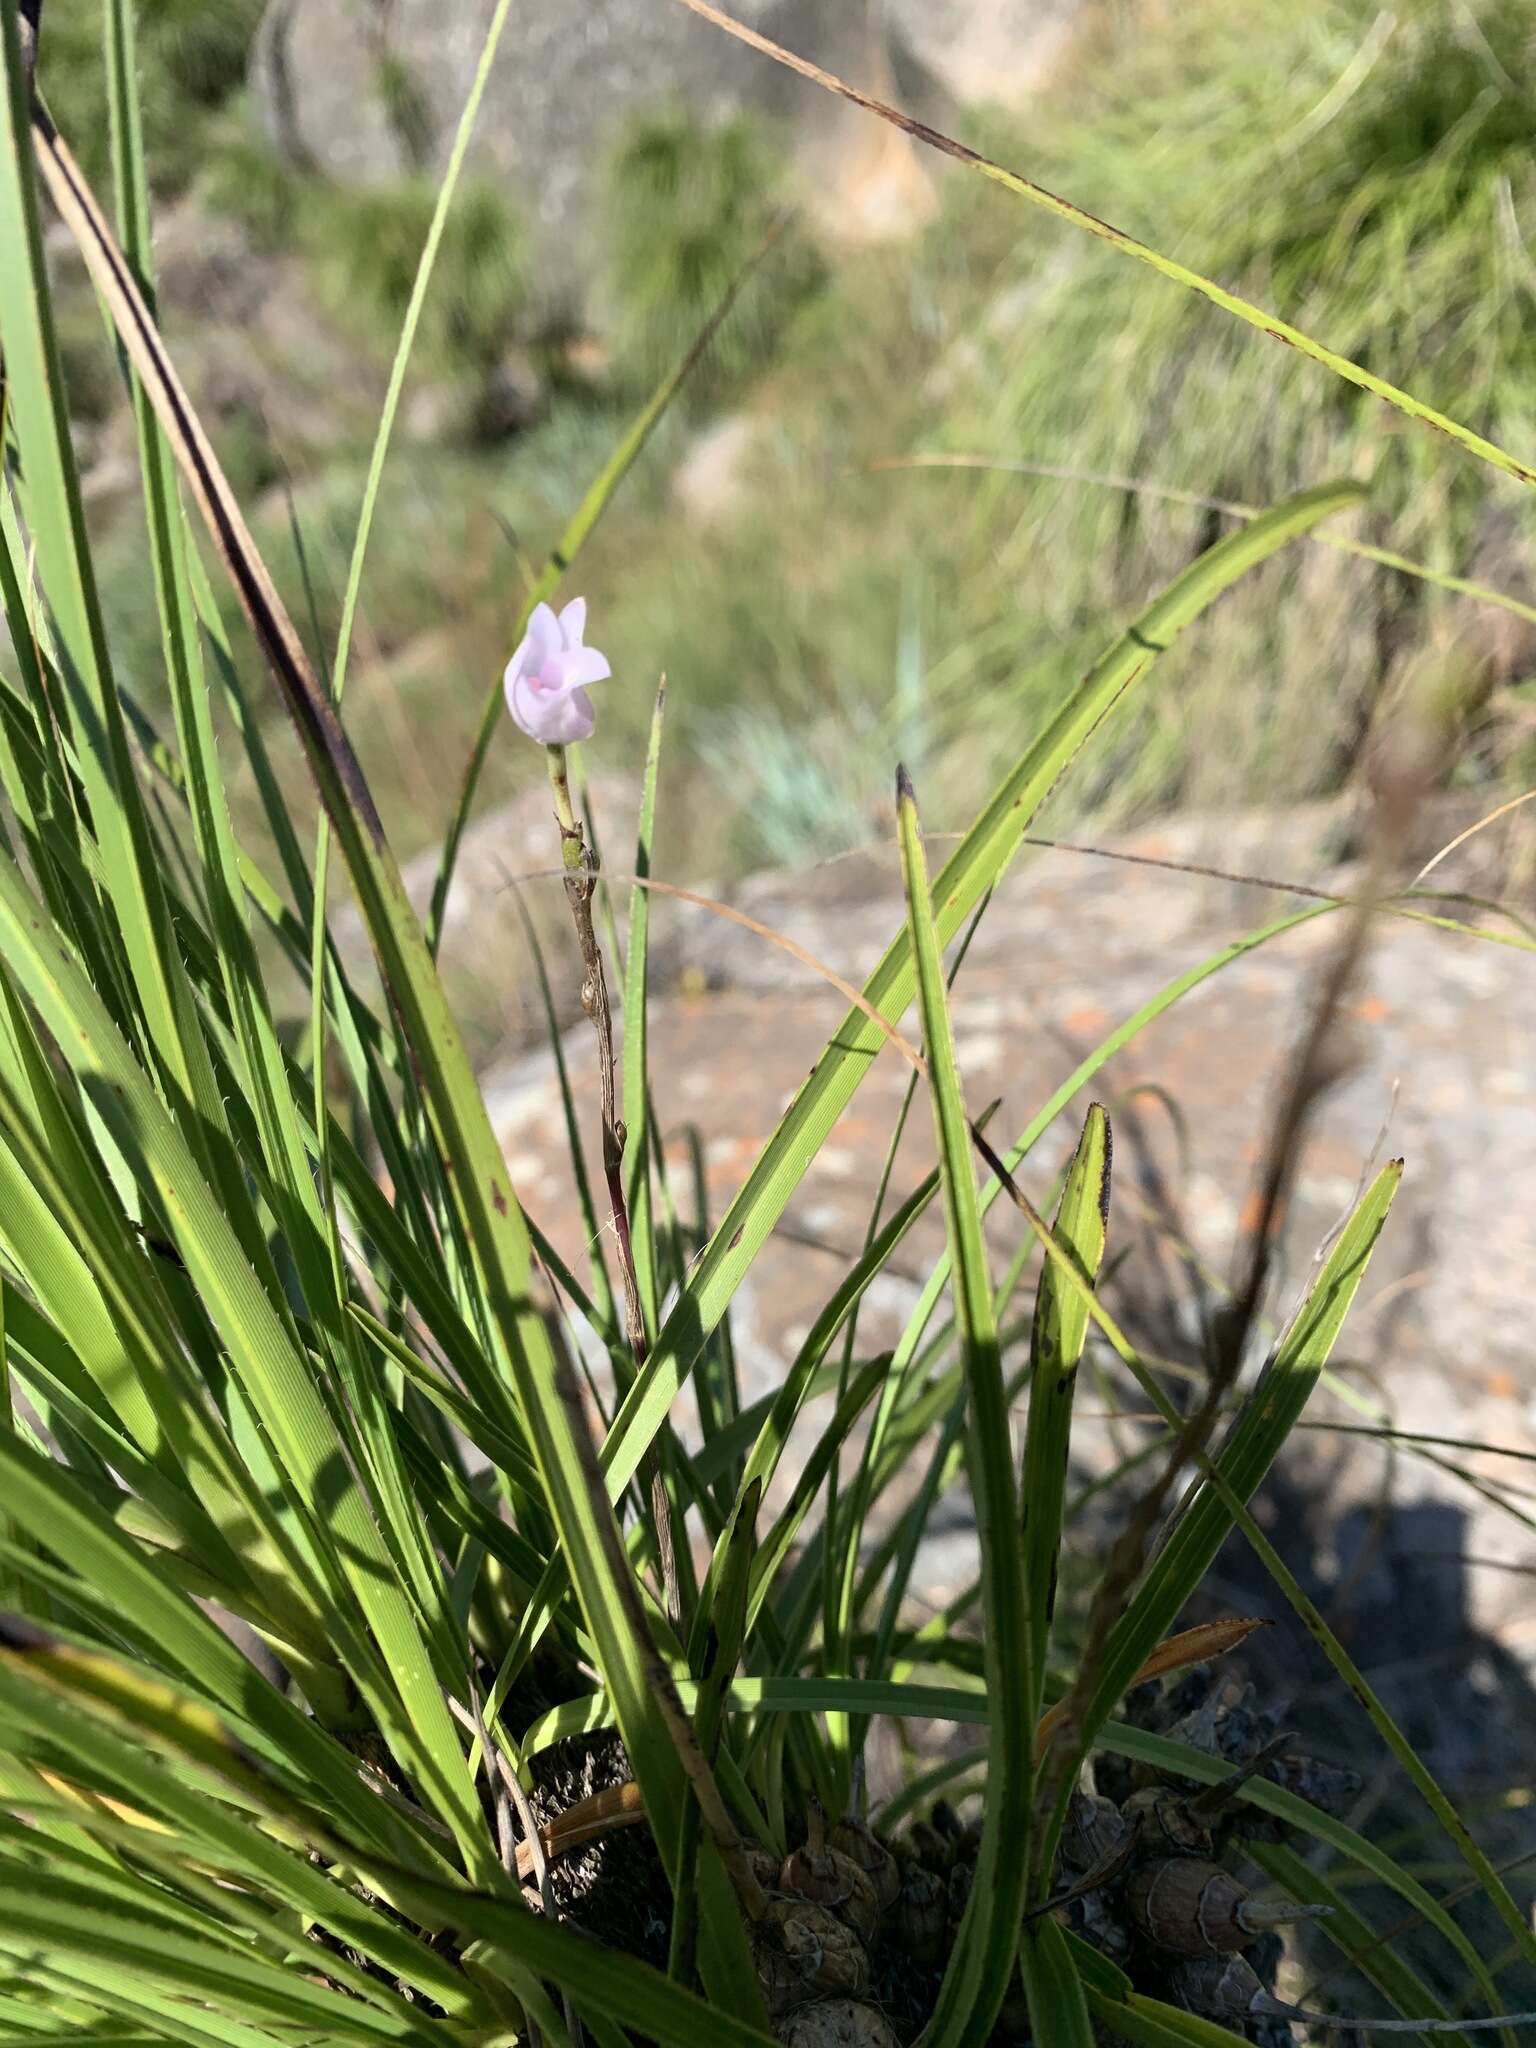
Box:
487 807 1536 1667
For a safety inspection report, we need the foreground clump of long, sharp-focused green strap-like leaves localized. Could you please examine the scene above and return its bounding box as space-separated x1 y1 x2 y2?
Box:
0 0 1536 2048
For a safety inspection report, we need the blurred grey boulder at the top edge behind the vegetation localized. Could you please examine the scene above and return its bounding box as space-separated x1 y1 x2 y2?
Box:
252 0 1083 285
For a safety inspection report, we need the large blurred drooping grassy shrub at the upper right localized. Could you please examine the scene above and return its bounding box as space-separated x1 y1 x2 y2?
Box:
962 0 1536 803
